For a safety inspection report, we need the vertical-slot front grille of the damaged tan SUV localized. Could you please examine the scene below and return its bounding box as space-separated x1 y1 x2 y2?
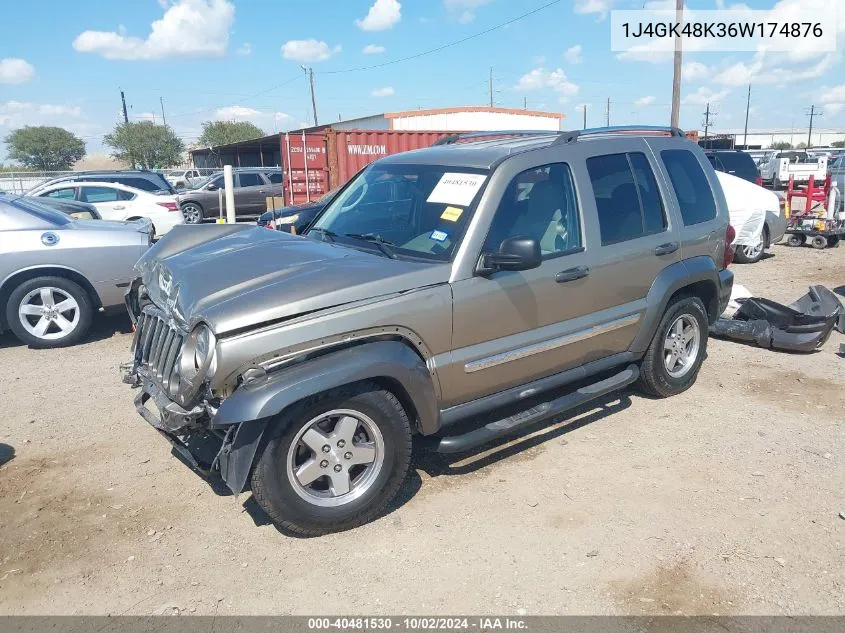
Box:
135 306 185 390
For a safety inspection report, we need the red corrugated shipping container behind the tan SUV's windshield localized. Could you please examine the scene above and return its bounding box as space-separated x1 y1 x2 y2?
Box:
282 128 455 205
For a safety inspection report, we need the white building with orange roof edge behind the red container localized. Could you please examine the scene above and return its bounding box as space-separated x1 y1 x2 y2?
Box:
330 106 564 132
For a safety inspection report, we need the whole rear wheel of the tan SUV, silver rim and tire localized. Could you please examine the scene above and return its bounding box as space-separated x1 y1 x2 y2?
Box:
639 296 708 398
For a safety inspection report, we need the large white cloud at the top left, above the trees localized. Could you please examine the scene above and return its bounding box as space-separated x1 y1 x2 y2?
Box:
73 0 235 60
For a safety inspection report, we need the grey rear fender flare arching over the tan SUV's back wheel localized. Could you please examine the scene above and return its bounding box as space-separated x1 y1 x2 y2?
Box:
630 255 730 354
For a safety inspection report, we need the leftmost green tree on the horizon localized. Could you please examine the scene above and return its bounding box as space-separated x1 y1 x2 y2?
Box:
4 125 85 171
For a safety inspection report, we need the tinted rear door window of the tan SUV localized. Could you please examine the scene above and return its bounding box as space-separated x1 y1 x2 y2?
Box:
587 152 666 245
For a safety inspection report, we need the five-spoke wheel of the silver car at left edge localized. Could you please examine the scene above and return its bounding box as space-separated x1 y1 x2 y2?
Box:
6 277 93 348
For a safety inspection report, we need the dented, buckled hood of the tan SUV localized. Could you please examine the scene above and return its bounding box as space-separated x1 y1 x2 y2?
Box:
136 225 449 334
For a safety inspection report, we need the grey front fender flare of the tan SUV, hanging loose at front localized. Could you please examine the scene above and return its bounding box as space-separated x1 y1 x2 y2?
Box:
212 341 440 494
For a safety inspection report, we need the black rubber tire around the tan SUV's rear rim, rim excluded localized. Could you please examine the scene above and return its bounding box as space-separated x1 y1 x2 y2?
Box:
638 296 708 398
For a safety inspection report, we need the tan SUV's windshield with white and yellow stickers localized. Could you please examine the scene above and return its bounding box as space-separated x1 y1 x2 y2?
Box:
308 163 487 262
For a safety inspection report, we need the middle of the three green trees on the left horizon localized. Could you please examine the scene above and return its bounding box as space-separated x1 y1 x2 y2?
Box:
103 121 185 169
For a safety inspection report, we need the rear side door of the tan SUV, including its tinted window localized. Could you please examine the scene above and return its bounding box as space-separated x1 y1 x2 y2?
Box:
584 138 682 336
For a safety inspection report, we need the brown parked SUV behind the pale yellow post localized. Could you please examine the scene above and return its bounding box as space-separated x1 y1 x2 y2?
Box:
179 167 284 224
